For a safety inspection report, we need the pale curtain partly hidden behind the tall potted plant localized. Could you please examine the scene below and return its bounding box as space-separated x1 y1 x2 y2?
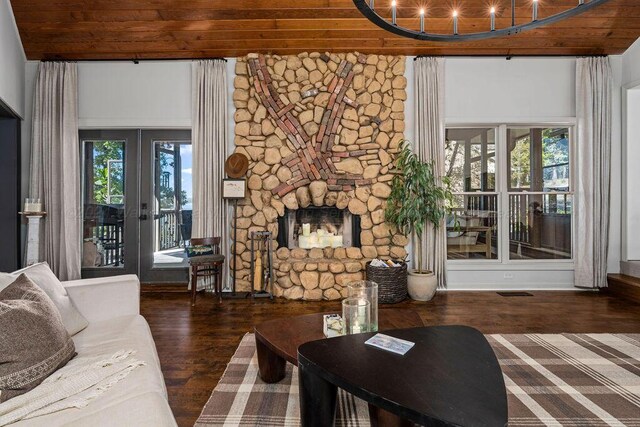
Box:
412 57 447 288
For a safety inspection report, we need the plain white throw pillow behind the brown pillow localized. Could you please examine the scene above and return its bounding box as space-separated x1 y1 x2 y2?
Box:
0 262 89 336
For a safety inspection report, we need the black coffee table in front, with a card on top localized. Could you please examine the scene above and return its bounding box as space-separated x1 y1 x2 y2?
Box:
298 326 507 427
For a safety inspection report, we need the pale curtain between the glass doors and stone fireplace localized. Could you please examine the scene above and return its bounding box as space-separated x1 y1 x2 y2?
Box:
191 59 231 287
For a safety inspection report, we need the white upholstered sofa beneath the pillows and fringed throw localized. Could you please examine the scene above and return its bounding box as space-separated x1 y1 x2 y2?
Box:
13 275 176 427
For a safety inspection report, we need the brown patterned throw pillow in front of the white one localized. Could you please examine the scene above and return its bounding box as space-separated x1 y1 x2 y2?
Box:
0 274 76 403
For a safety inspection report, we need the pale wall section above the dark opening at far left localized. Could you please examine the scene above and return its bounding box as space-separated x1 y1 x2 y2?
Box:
0 0 26 117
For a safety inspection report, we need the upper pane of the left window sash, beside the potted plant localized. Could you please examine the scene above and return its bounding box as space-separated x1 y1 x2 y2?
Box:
445 128 496 192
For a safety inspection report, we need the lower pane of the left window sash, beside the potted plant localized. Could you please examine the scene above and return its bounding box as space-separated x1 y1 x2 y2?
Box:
447 194 499 259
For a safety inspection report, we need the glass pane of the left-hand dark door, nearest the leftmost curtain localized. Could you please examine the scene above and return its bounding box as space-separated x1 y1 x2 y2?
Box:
82 141 125 268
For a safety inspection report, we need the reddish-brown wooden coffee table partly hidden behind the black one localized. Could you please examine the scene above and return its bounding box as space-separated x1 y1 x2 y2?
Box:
254 308 424 383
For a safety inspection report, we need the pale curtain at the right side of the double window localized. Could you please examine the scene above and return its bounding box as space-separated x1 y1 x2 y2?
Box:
575 57 613 288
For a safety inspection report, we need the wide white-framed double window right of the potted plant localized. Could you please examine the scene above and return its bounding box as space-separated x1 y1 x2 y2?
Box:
445 125 573 262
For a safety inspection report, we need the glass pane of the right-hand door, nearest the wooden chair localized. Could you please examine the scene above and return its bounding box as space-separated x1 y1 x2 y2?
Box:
154 141 193 267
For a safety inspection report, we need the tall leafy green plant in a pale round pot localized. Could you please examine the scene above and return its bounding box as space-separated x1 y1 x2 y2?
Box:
385 141 453 301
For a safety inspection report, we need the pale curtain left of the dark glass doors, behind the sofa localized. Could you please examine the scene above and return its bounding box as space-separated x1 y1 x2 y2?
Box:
29 62 82 280
